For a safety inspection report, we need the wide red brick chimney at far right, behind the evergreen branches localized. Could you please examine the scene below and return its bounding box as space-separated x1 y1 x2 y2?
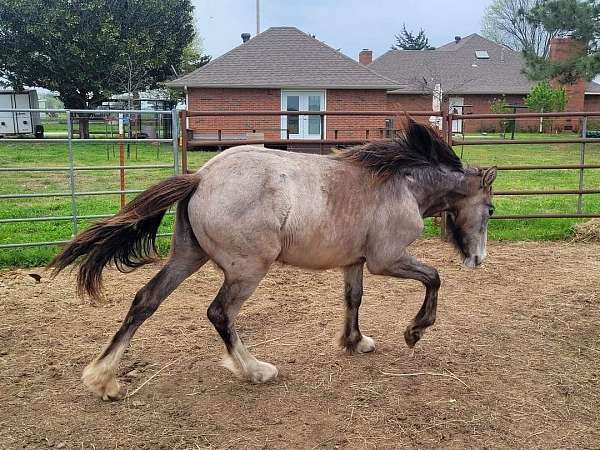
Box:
550 37 586 131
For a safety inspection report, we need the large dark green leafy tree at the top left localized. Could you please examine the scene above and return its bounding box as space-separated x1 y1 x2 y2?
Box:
0 0 200 136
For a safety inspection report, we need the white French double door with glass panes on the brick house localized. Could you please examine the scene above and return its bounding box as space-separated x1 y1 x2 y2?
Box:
281 91 325 139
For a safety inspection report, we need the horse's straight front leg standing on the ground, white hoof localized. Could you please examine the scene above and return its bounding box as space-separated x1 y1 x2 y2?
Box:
340 262 375 353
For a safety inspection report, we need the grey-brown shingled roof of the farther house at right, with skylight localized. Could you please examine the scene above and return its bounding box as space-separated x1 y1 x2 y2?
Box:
369 34 534 95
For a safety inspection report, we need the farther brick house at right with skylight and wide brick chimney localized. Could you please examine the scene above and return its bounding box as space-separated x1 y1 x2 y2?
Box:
368 34 600 132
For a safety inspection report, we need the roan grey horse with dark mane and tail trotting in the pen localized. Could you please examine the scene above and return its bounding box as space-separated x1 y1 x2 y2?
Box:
49 118 496 400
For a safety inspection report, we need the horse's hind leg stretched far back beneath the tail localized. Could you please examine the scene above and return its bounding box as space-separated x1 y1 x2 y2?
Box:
82 246 208 400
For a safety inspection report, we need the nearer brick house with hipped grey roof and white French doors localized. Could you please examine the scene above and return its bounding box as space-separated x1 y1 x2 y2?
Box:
169 27 399 140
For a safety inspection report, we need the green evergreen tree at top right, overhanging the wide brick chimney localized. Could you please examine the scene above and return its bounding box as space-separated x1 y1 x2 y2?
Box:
526 0 600 84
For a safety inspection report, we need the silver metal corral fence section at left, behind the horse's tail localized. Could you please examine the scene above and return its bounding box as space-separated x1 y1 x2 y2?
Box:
0 109 180 249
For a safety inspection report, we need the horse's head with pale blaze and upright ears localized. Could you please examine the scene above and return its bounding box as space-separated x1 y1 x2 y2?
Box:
447 167 497 267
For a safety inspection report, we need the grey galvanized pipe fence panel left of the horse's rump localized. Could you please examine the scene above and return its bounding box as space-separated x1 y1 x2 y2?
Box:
0 109 181 249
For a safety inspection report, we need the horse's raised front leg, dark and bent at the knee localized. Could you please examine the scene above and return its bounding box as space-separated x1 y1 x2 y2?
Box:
367 256 440 348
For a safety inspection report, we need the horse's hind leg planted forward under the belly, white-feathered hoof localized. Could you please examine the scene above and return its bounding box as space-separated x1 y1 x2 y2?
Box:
207 262 277 383
